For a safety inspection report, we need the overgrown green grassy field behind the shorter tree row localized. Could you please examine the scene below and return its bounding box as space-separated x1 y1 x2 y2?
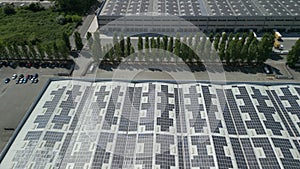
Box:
0 8 78 45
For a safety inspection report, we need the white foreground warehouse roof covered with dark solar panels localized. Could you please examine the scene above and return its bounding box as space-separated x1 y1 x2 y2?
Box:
0 80 300 169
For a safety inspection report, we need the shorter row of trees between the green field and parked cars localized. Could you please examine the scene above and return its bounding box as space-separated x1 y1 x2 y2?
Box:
0 33 71 60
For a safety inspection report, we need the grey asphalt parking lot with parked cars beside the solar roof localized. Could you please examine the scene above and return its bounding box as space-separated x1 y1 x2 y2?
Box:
0 67 67 152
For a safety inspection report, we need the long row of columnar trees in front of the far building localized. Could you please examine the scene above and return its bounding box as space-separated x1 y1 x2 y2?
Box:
90 32 274 64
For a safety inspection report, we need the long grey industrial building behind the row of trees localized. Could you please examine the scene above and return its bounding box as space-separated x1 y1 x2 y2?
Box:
97 0 300 33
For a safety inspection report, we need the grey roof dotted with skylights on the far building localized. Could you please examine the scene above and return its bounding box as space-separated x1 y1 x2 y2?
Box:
100 0 300 16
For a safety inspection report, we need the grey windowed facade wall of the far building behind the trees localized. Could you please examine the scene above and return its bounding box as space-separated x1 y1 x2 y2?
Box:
98 16 300 32
